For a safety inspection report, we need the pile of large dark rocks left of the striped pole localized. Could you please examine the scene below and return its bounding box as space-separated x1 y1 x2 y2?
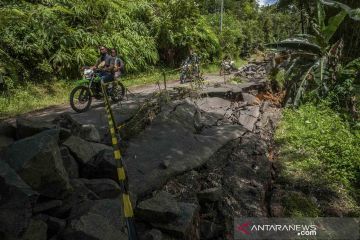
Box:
0 118 127 240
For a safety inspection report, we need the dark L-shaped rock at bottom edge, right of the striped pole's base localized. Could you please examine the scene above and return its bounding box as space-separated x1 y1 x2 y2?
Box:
151 203 199 239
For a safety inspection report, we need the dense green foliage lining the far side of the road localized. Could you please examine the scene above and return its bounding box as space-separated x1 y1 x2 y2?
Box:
0 0 297 88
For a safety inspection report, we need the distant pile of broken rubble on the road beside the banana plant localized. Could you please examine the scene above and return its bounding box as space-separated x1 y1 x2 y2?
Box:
235 61 271 80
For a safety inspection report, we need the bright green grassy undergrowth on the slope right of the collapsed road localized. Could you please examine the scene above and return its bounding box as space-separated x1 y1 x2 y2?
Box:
275 104 360 216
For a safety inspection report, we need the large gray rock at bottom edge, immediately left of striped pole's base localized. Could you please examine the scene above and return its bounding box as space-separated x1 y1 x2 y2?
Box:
63 199 128 240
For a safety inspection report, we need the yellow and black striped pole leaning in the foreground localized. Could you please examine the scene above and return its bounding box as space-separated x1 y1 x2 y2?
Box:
101 84 138 240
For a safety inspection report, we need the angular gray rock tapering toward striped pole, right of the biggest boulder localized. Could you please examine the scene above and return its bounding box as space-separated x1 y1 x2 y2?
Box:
63 136 112 165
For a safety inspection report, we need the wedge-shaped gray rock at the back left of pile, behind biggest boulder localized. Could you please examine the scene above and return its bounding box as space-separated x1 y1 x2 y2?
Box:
16 118 56 139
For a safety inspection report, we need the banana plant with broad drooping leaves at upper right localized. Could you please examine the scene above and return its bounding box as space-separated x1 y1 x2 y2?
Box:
267 0 360 106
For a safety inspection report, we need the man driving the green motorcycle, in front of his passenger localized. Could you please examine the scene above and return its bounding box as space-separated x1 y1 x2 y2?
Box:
91 46 114 83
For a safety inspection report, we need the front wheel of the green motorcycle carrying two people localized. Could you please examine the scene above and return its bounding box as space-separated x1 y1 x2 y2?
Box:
70 86 92 113
